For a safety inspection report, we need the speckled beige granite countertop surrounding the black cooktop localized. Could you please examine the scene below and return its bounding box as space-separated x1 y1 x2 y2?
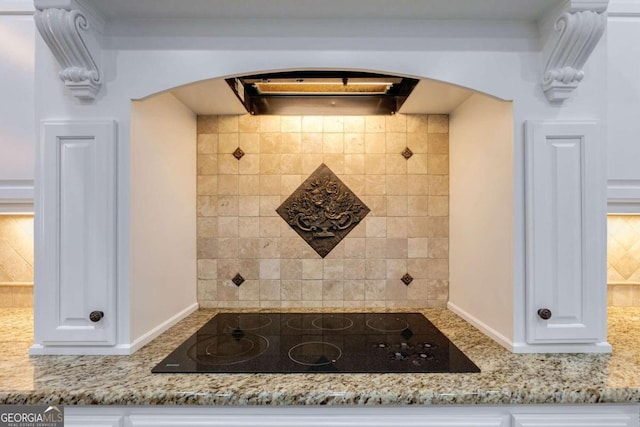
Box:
0 308 640 405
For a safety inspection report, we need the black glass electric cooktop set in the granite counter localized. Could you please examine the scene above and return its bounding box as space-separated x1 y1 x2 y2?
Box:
152 313 480 373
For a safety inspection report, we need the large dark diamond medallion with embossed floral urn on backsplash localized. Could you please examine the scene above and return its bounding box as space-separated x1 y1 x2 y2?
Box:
276 163 369 258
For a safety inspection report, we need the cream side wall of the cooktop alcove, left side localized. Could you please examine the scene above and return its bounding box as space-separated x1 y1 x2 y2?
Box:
129 94 196 342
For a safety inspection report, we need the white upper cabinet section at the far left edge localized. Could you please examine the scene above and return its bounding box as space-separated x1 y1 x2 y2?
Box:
0 0 36 212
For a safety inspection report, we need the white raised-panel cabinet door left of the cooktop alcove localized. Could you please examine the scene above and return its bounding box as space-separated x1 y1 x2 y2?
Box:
34 121 116 345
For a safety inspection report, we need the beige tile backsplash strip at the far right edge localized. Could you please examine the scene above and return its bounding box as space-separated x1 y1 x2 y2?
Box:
607 215 640 307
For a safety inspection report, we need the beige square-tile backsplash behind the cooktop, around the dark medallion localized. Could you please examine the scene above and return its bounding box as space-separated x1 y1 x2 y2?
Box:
197 114 449 308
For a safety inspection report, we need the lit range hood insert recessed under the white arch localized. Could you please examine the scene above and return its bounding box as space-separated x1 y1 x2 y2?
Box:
227 71 418 115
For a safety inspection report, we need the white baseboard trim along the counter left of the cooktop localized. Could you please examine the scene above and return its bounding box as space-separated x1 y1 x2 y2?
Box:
29 303 199 356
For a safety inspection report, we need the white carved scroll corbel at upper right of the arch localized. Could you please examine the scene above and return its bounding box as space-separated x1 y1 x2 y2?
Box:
539 0 609 102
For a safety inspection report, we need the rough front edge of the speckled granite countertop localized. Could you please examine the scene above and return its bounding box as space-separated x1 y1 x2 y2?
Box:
0 388 640 406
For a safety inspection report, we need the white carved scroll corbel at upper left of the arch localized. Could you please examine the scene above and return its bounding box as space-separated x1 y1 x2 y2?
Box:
34 1 102 100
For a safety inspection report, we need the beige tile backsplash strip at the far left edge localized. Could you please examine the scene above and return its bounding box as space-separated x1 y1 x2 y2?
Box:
0 215 33 307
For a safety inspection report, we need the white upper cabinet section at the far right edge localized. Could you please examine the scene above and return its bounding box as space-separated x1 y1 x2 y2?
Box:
607 0 640 213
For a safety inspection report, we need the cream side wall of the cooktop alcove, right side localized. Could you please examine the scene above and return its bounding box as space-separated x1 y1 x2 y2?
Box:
449 94 514 347
